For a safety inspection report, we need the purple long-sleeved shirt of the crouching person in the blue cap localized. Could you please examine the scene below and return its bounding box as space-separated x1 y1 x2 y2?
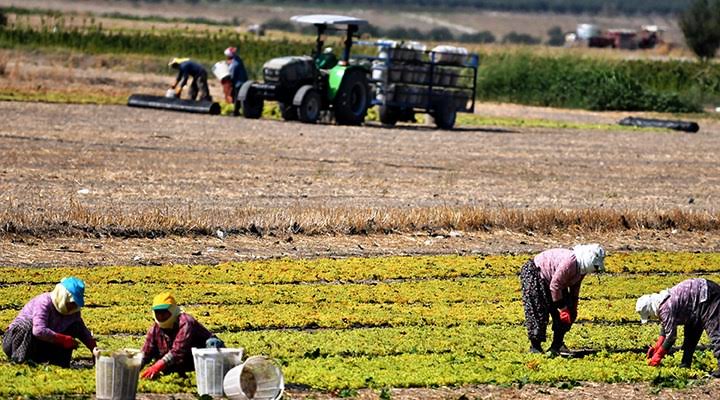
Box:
10 293 95 349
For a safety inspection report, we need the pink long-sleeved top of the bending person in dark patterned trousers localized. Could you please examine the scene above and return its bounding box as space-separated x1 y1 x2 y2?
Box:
533 249 585 305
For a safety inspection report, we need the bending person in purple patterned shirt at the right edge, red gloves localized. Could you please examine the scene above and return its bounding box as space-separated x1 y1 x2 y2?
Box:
635 278 720 378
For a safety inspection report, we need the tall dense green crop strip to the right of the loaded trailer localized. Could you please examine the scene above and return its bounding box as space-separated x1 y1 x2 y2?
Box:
478 53 720 112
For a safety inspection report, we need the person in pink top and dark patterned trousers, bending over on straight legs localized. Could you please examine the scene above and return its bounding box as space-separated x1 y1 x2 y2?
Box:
520 244 605 354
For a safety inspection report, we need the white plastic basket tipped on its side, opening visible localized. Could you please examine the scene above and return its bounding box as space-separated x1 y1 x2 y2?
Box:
223 356 285 400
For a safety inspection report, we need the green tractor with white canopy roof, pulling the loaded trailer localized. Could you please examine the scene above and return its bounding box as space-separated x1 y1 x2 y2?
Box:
236 15 372 125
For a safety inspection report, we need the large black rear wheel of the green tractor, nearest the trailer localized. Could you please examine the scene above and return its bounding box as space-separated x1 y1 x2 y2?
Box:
333 69 369 125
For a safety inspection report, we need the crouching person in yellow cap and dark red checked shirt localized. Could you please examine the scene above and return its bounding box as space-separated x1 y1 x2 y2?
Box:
141 292 225 379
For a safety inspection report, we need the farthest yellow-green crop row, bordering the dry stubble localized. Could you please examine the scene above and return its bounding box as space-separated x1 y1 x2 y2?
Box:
0 252 720 285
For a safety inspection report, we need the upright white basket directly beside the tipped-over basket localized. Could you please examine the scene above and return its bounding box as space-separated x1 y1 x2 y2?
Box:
192 347 243 397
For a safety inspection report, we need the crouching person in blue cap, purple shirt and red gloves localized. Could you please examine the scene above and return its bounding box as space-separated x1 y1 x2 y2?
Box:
3 276 97 367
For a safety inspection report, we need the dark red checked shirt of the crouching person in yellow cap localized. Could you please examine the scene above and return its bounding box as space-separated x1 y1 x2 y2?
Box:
142 313 215 371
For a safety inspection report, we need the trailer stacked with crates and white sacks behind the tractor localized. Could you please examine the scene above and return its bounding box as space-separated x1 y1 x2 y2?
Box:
365 41 479 129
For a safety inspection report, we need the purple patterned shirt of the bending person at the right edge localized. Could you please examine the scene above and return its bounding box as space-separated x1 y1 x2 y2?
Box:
658 278 708 350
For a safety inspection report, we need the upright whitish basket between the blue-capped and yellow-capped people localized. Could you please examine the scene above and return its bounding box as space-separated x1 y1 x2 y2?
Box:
95 349 143 400
